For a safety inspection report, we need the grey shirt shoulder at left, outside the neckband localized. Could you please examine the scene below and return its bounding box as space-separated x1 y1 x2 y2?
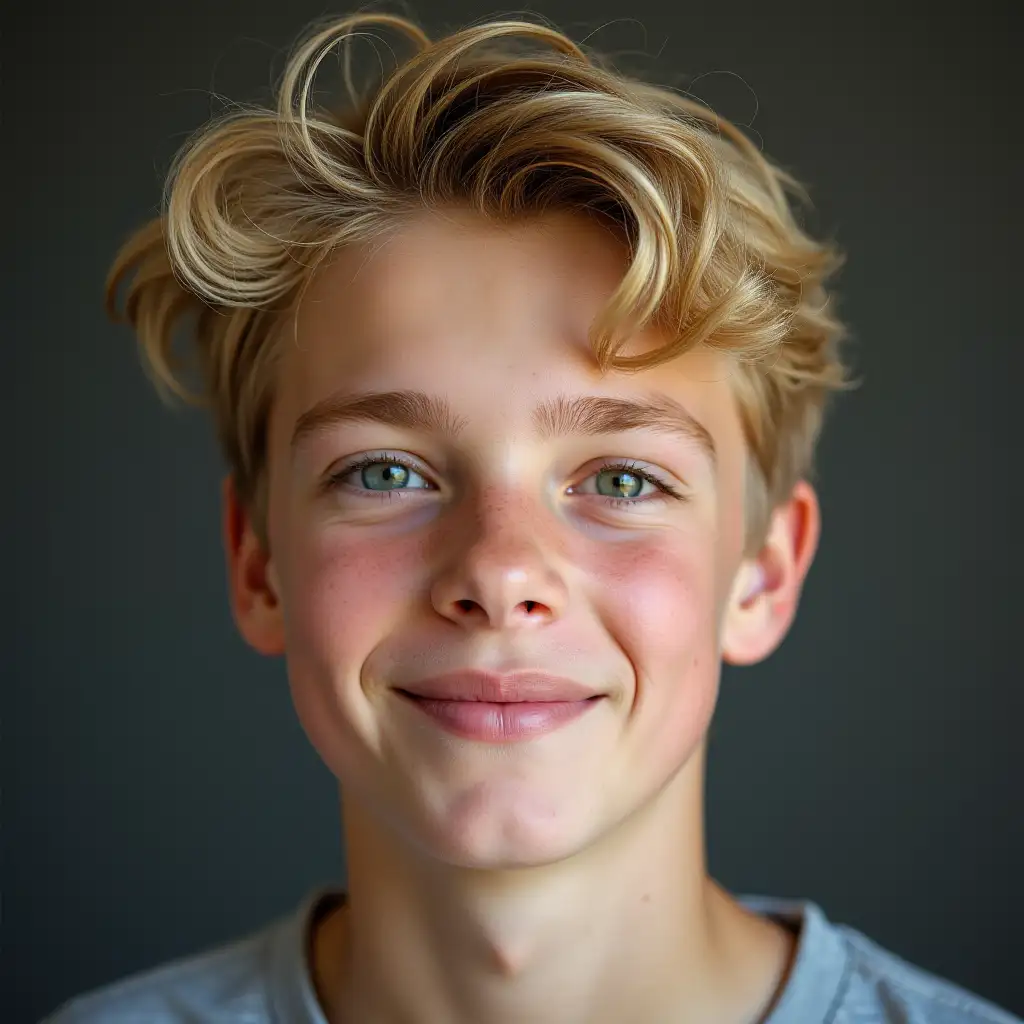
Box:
41 928 272 1024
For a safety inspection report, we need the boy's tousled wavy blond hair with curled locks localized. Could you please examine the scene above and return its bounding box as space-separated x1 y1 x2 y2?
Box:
106 13 846 554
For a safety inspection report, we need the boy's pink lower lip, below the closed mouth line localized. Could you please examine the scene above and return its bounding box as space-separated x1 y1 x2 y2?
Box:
402 693 601 743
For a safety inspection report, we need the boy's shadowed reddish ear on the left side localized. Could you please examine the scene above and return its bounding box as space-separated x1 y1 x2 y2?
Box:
221 475 285 654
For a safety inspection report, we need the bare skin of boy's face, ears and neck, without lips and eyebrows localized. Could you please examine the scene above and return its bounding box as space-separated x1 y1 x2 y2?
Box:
223 212 819 1024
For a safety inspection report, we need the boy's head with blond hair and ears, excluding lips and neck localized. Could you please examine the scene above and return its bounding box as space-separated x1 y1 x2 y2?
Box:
109 15 844 865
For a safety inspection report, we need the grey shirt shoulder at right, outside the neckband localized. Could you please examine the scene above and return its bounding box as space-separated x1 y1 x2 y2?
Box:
836 926 1022 1024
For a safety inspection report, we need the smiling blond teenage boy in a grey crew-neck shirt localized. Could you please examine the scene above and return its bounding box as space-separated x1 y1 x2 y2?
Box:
41 9 1024 1024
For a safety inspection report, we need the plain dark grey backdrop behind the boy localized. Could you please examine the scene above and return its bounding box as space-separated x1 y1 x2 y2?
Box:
0 0 1024 1024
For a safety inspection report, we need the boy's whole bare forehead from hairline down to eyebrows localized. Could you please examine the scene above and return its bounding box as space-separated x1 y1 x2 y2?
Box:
279 211 736 454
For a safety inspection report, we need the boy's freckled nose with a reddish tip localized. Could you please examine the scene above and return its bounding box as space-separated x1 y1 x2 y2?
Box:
431 497 566 630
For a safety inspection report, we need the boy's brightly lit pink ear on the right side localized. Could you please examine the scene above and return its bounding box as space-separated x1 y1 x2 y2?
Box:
722 480 821 665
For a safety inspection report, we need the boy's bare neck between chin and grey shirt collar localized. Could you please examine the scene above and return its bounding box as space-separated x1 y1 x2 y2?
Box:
313 759 792 1024
